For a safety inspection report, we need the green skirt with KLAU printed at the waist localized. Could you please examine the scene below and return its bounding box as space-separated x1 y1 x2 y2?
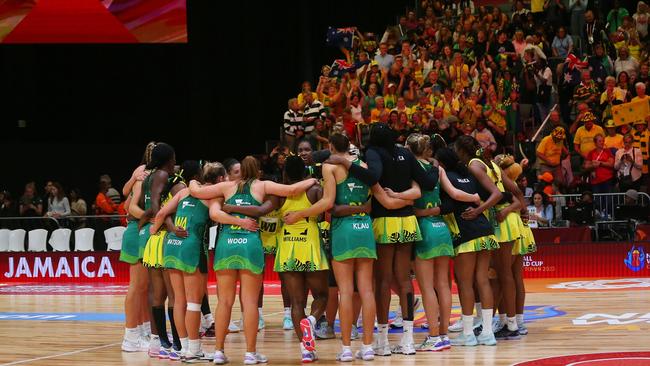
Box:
330 215 377 262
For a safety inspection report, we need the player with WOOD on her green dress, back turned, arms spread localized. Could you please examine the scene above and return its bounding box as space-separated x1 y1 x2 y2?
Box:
190 156 315 364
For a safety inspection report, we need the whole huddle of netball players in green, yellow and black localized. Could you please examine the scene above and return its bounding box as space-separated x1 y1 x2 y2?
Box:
120 123 535 364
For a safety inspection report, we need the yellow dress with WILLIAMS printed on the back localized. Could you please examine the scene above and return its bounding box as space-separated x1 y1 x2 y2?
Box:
274 192 330 272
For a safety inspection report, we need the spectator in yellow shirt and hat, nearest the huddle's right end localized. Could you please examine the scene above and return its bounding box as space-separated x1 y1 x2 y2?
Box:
537 127 569 186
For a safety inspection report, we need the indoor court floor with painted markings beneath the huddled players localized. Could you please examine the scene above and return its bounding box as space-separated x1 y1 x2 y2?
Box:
0 278 650 366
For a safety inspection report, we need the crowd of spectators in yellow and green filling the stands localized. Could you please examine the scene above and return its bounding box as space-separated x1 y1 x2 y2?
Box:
276 0 650 223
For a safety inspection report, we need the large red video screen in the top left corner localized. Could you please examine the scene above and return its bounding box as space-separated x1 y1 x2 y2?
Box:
0 0 187 43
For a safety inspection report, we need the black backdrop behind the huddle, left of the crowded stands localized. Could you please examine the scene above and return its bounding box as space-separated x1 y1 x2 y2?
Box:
0 0 404 200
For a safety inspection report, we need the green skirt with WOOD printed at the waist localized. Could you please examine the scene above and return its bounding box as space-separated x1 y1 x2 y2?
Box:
213 225 264 274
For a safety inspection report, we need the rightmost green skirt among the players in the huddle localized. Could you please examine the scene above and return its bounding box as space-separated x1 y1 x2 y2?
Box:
415 216 454 259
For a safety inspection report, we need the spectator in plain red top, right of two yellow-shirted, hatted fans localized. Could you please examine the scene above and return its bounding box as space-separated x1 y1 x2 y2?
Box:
584 134 614 194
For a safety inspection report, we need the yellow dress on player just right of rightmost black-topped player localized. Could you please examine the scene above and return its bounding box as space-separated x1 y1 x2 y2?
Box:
469 159 522 243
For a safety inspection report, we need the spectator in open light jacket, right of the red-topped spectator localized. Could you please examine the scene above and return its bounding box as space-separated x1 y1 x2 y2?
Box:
614 134 643 192
